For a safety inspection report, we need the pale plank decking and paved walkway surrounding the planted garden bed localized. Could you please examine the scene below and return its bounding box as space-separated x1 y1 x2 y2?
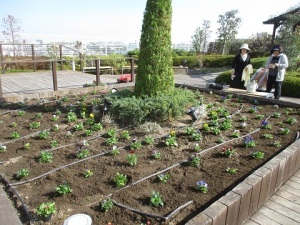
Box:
0 71 300 225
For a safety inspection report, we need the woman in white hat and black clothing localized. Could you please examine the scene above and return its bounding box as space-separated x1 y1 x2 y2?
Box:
230 44 251 89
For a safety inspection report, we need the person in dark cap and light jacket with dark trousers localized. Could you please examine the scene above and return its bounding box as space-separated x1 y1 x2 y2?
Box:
265 45 289 99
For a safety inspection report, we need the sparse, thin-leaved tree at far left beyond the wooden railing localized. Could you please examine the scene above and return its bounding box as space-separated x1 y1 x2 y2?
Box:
2 15 22 57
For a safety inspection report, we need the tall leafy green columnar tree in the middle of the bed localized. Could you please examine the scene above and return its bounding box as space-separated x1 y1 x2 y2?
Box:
135 0 174 96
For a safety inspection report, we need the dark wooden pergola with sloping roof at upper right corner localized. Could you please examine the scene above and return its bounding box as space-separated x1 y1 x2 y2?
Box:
263 7 300 45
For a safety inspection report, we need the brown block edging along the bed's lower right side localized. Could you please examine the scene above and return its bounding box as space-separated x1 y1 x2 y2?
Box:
186 139 300 225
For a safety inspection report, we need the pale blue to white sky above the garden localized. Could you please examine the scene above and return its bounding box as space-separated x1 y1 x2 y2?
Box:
0 0 300 43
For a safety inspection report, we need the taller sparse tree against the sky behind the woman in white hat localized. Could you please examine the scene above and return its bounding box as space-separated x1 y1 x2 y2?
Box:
217 10 242 55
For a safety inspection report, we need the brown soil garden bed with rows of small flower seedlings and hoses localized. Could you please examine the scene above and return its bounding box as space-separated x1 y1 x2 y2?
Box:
0 89 300 224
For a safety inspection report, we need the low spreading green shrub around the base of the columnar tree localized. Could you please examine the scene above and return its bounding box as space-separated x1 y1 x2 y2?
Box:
109 89 197 125
